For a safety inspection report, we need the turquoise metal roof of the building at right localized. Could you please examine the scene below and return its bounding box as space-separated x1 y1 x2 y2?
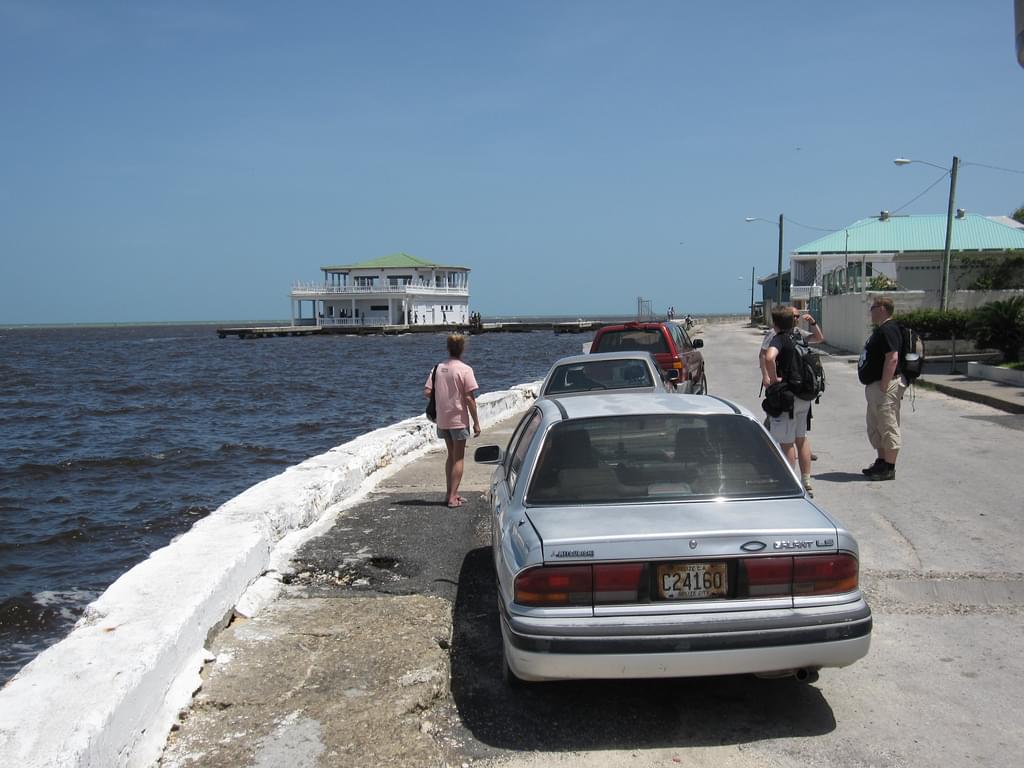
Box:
793 213 1024 256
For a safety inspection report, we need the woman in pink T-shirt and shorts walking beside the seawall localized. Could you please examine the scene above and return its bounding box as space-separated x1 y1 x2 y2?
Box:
423 334 480 508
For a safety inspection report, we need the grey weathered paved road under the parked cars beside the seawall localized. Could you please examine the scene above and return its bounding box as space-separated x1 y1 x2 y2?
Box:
164 326 1024 768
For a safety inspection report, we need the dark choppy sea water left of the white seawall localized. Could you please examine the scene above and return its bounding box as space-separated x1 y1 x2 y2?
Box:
0 325 591 683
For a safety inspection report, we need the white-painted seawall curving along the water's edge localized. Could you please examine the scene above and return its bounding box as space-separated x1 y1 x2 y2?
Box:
0 382 539 768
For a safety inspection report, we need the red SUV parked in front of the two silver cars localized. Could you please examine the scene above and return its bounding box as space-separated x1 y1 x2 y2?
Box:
590 323 708 394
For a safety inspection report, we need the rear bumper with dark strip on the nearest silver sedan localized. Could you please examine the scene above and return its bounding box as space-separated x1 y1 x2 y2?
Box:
502 600 871 680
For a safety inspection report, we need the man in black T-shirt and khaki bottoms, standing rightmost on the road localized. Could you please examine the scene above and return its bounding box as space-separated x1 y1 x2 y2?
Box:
857 296 907 480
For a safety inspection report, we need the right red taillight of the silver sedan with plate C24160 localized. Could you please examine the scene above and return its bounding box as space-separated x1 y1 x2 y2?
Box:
736 555 858 597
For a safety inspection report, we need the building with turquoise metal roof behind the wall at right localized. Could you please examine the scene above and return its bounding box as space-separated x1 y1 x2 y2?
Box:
791 210 1024 306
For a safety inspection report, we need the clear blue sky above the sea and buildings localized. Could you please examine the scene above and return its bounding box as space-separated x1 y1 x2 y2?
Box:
0 0 1024 324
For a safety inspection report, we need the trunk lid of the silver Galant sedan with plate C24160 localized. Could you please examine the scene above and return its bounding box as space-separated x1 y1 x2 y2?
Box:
528 498 843 615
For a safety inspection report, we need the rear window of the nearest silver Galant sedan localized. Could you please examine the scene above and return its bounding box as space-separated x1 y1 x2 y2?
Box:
526 414 802 506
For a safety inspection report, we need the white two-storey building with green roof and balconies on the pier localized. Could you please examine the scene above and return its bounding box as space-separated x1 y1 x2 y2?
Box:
290 253 469 326
